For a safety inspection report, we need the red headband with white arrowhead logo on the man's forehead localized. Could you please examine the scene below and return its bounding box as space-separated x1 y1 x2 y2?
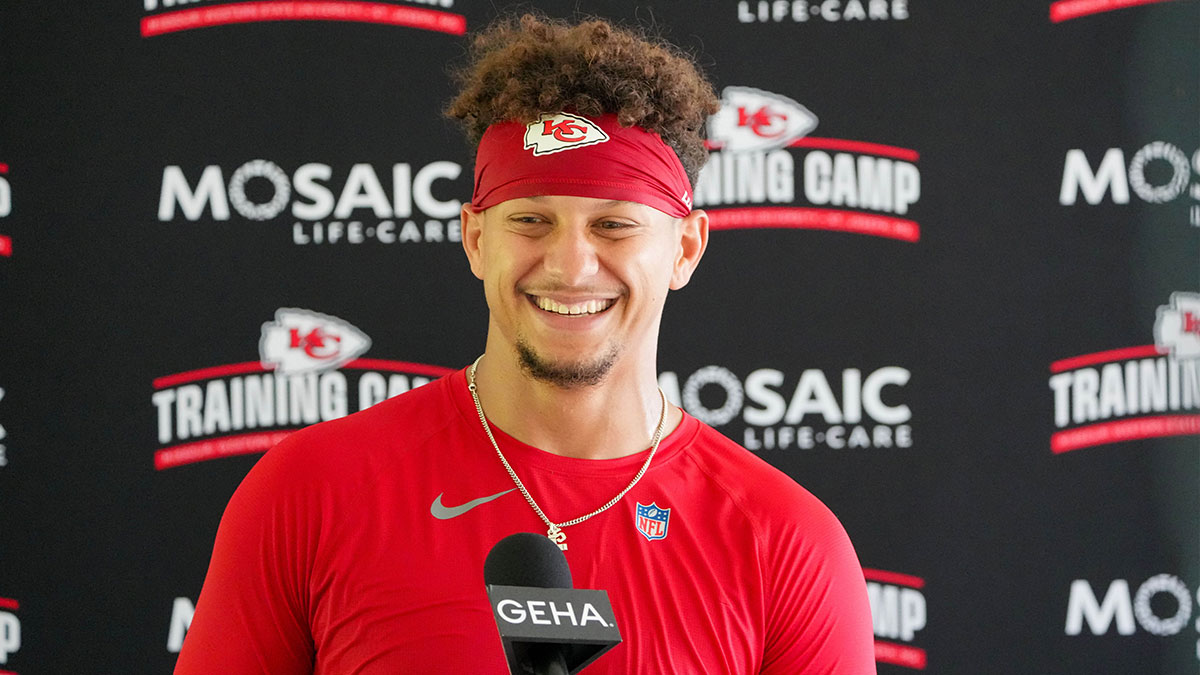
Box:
470 113 691 217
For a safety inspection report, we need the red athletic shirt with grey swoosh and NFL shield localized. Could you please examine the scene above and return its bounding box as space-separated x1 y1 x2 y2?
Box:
175 371 875 675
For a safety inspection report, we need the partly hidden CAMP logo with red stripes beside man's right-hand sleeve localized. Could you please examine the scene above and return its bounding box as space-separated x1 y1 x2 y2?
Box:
863 568 929 670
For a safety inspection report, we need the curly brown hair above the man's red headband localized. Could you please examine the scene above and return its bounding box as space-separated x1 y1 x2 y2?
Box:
446 14 719 184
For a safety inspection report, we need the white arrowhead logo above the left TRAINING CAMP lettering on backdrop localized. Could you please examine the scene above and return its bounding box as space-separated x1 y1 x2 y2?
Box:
258 307 371 375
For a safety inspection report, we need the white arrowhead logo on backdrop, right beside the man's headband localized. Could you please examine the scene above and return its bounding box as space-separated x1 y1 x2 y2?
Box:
708 86 817 153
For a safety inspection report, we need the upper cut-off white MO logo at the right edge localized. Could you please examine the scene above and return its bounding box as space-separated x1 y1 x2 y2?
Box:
1058 141 1200 227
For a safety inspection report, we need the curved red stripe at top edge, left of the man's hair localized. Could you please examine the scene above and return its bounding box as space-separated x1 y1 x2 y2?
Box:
142 0 467 37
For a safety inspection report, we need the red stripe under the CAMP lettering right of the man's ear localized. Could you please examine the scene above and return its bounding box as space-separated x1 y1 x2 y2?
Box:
708 207 920 243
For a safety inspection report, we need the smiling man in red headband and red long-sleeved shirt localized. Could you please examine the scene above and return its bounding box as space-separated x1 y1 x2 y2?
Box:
176 11 875 675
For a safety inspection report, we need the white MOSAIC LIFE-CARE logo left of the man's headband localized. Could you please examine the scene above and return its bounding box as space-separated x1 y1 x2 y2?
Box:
158 160 462 245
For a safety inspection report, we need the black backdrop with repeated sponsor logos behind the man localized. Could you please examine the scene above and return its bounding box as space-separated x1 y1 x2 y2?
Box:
0 0 1200 675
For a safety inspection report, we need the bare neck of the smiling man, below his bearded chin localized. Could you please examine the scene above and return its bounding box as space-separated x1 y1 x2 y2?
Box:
465 340 683 459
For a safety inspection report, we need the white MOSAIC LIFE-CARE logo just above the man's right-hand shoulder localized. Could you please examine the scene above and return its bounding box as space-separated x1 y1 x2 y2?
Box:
659 365 912 450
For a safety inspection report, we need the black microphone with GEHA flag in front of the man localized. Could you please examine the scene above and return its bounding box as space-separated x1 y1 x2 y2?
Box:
484 532 620 675
